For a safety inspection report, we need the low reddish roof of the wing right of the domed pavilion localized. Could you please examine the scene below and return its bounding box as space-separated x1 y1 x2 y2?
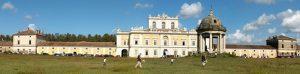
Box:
226 45 276 49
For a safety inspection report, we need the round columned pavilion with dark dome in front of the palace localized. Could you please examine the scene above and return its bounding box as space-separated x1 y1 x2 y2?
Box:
197 9 226 53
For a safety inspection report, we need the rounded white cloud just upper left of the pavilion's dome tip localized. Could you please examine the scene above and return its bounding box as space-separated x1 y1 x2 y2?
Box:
180 2 203 18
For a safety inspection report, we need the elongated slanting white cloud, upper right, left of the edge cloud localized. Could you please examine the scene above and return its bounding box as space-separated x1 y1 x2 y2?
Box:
243 14 276 31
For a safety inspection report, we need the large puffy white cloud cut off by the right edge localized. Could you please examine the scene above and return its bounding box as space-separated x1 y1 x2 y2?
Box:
277 9 300 33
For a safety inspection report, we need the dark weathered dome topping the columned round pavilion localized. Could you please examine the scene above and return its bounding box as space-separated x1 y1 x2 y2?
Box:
197 10 226 32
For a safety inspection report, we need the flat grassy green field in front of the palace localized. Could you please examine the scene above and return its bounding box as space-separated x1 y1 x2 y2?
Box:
0 54 300 74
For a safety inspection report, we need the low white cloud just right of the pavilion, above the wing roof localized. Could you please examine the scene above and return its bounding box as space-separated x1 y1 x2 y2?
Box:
228 29 253 44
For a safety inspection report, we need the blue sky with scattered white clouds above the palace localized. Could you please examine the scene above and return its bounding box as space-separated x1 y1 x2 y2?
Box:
0 0 300 44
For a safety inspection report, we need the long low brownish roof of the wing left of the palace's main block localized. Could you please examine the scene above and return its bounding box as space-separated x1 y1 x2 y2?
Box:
37 42 116 47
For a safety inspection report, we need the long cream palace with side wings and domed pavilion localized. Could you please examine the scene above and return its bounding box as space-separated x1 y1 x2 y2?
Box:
0 10 300 58
